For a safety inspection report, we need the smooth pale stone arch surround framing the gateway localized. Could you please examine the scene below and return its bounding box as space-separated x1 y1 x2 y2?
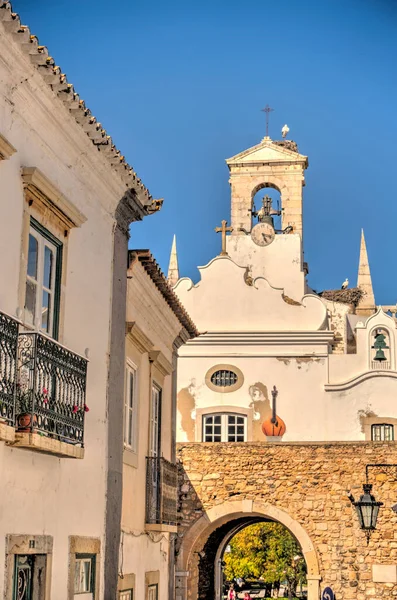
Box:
176 499 321 600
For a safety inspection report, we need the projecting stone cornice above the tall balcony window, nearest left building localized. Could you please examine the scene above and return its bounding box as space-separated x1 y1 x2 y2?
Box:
21 167 87 229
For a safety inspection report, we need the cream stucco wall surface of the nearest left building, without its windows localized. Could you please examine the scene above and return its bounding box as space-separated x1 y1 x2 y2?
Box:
0 23 136 599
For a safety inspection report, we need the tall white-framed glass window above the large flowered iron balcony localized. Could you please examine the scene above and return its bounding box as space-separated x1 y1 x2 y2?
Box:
25 219 62 338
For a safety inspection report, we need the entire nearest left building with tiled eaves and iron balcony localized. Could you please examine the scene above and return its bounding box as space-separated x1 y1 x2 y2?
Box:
0 2 160 600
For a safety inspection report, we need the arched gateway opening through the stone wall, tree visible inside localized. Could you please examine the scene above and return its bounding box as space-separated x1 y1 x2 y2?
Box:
198 516 307 600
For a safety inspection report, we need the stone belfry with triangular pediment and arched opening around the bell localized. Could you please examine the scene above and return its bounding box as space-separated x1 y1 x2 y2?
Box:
226 137 309 237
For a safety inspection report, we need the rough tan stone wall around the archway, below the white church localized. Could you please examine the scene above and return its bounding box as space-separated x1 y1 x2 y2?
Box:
177 442 397 600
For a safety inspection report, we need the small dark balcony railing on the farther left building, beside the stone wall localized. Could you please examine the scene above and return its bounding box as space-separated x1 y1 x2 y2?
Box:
146 456 178 525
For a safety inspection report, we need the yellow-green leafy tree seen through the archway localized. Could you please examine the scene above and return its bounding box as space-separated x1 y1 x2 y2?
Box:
223 522 306 598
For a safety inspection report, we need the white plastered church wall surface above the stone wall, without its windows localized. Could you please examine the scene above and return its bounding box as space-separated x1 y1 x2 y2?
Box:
174 146 397 442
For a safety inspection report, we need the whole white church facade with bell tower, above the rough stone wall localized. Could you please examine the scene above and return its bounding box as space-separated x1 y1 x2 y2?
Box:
174 138 397 442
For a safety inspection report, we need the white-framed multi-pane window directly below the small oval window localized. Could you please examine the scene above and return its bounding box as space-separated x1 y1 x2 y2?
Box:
203 413 247 442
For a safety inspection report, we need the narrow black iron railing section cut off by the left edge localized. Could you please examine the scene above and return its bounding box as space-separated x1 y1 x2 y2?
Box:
0 312 19 427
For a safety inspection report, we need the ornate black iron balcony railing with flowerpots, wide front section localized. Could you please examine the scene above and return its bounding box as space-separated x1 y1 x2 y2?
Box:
16 333 87 447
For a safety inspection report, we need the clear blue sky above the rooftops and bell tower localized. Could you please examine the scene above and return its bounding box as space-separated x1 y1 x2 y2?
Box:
13 0 397 304
